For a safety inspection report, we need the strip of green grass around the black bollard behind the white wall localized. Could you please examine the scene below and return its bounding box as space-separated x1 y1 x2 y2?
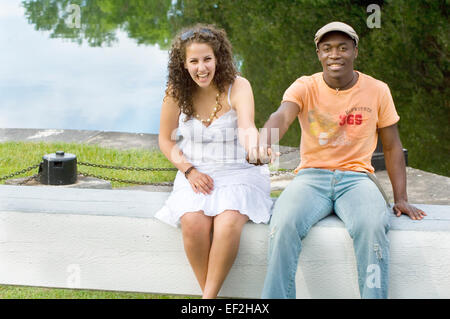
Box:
0 142 176 188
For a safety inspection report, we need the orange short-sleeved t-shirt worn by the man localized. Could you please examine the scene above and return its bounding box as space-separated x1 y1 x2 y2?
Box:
283 72 400 173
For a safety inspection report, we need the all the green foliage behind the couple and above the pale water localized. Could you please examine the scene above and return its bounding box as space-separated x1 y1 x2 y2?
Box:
24 0 450 176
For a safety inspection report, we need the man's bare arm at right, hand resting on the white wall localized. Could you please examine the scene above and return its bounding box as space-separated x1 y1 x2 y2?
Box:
378 124 427 220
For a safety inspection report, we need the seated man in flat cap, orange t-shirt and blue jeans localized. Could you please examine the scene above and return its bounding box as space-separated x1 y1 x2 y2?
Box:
262 22 426 298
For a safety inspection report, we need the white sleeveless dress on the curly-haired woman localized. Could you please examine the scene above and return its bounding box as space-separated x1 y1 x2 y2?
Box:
155 89 273 227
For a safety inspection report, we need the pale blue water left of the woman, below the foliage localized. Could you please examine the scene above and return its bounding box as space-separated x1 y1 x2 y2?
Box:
0 0 168 134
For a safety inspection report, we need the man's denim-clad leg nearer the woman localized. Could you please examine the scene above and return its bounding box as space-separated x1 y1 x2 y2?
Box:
262 169 332 298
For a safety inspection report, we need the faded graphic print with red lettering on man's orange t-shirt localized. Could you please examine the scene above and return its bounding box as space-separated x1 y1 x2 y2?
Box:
308 107 372 146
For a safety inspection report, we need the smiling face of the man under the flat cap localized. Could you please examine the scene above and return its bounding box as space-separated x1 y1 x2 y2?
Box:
316 32 358 79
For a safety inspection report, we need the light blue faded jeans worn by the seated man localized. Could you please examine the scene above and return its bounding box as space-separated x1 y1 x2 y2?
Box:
262 168 390 298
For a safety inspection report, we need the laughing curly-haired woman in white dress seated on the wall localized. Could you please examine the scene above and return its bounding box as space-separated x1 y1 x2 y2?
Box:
156 25 272 298
